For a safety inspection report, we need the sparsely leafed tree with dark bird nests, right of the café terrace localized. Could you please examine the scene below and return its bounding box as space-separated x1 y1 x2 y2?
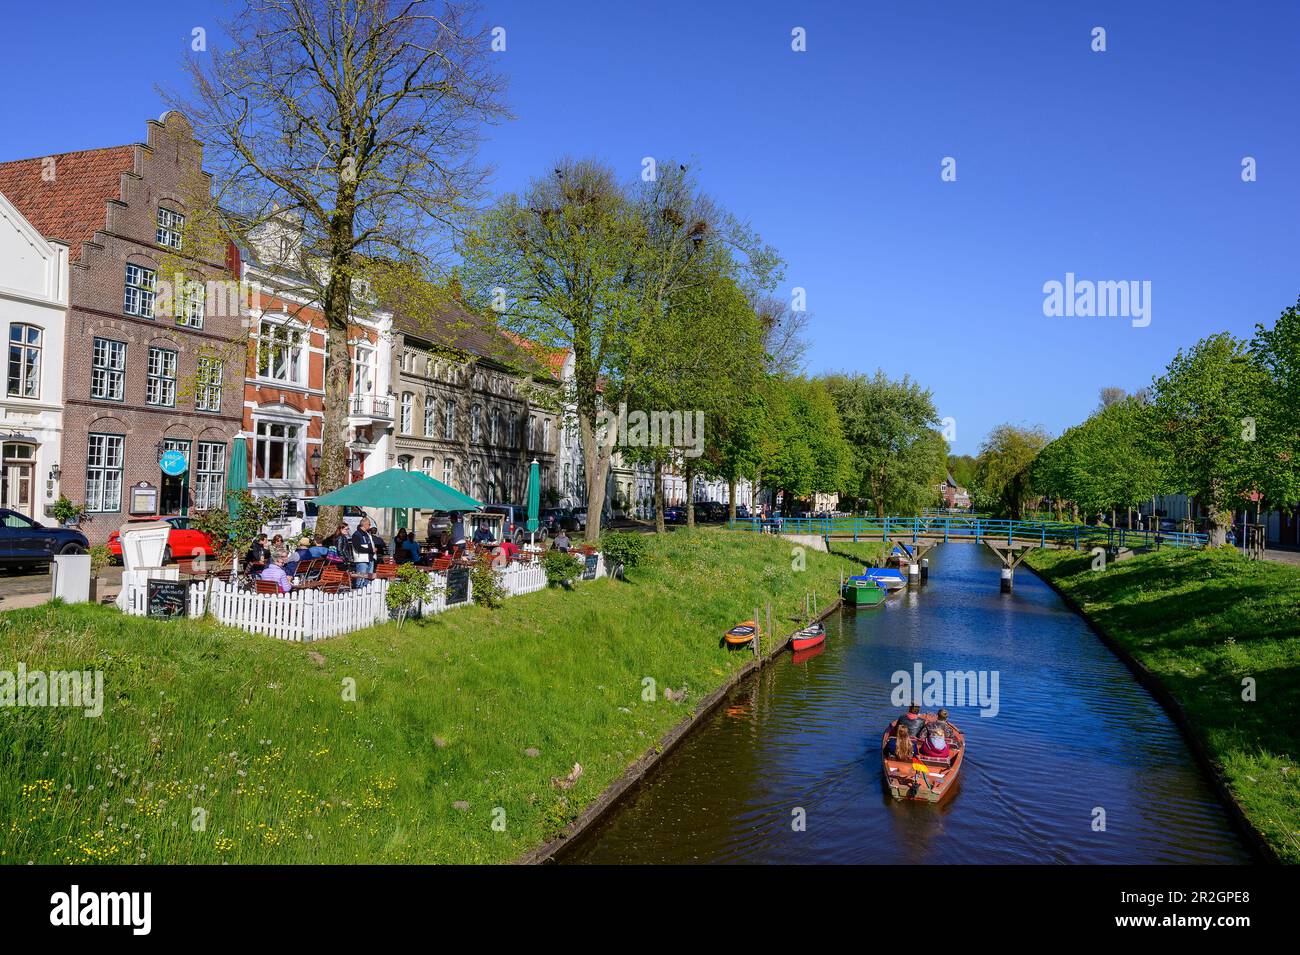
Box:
462 160 779 543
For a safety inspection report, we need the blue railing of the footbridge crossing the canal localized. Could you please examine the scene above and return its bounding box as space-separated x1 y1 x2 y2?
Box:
727 516 1209 550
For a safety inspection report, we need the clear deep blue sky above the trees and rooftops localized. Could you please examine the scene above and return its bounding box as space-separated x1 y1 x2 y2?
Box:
0 0 1300 452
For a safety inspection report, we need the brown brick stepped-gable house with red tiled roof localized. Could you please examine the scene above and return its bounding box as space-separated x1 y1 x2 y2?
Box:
0 112 247 543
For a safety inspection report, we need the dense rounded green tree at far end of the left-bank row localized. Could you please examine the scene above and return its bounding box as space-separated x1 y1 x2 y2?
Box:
827 370 948 517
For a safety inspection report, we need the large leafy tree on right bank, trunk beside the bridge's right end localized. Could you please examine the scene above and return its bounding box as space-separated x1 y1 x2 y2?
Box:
1152 333 1268 546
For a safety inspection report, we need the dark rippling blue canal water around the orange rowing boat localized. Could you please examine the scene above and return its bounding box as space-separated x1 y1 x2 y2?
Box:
559 543 1249 864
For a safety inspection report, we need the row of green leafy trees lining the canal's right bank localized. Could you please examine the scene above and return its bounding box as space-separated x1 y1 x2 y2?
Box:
974 301 1300 543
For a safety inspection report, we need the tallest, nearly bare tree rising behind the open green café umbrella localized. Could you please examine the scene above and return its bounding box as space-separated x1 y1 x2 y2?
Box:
172 0 504 524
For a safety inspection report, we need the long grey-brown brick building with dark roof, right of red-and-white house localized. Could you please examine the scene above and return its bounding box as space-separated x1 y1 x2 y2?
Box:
391 309 564 533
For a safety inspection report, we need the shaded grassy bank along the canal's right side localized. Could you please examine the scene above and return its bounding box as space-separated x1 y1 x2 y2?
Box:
1026 550 1300 863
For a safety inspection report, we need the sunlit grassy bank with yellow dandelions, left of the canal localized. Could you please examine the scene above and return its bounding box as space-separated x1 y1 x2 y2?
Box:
0 530 863 863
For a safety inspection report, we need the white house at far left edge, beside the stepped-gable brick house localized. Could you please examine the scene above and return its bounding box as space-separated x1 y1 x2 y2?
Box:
0 194 68 521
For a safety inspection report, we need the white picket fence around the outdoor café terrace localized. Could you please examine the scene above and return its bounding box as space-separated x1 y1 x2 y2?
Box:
117 559 605 643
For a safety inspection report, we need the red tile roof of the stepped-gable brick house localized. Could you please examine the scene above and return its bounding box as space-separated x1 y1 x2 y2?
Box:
0 146 135 262
